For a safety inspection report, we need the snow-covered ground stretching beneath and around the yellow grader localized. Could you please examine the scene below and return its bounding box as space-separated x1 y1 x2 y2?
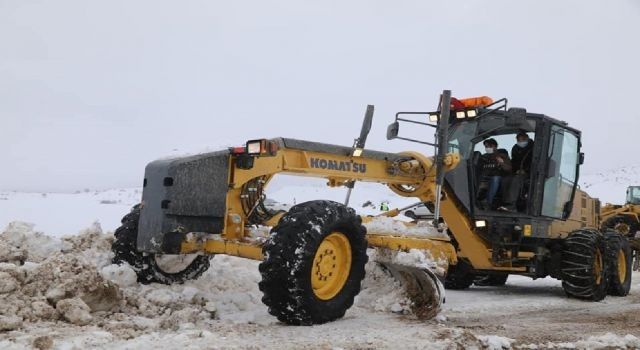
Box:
0 175 640 349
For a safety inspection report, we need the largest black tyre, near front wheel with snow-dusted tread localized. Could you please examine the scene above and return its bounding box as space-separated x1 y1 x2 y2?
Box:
259 200 368 325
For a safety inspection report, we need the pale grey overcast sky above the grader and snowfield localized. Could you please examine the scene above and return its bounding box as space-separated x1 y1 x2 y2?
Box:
0 0 640 191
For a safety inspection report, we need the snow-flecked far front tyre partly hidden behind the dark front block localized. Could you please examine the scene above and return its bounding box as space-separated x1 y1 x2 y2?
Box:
111 205 210 284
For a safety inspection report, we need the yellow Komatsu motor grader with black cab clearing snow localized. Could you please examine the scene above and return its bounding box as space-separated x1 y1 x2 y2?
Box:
112 90 631 325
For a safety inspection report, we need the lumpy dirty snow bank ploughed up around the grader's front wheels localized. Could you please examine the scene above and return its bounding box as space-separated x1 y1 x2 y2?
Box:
0 222 422 337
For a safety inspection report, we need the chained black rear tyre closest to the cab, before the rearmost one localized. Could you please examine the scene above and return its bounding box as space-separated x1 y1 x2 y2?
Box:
562 229 610 301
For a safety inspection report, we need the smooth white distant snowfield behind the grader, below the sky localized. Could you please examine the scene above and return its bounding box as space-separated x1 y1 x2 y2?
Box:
0 166 640 235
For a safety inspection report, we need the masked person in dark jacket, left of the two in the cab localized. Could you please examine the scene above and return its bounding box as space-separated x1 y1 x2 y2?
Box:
479 138 512 209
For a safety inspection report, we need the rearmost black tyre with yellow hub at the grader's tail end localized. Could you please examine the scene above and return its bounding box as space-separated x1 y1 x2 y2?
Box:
606 232 633 297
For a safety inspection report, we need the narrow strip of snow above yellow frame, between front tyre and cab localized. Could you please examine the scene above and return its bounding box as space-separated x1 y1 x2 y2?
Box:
363 216 449 239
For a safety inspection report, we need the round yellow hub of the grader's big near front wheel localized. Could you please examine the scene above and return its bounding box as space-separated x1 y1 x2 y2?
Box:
311 232 351 300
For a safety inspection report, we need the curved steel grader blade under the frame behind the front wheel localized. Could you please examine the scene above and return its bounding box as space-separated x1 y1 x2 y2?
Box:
377 261 445 320
